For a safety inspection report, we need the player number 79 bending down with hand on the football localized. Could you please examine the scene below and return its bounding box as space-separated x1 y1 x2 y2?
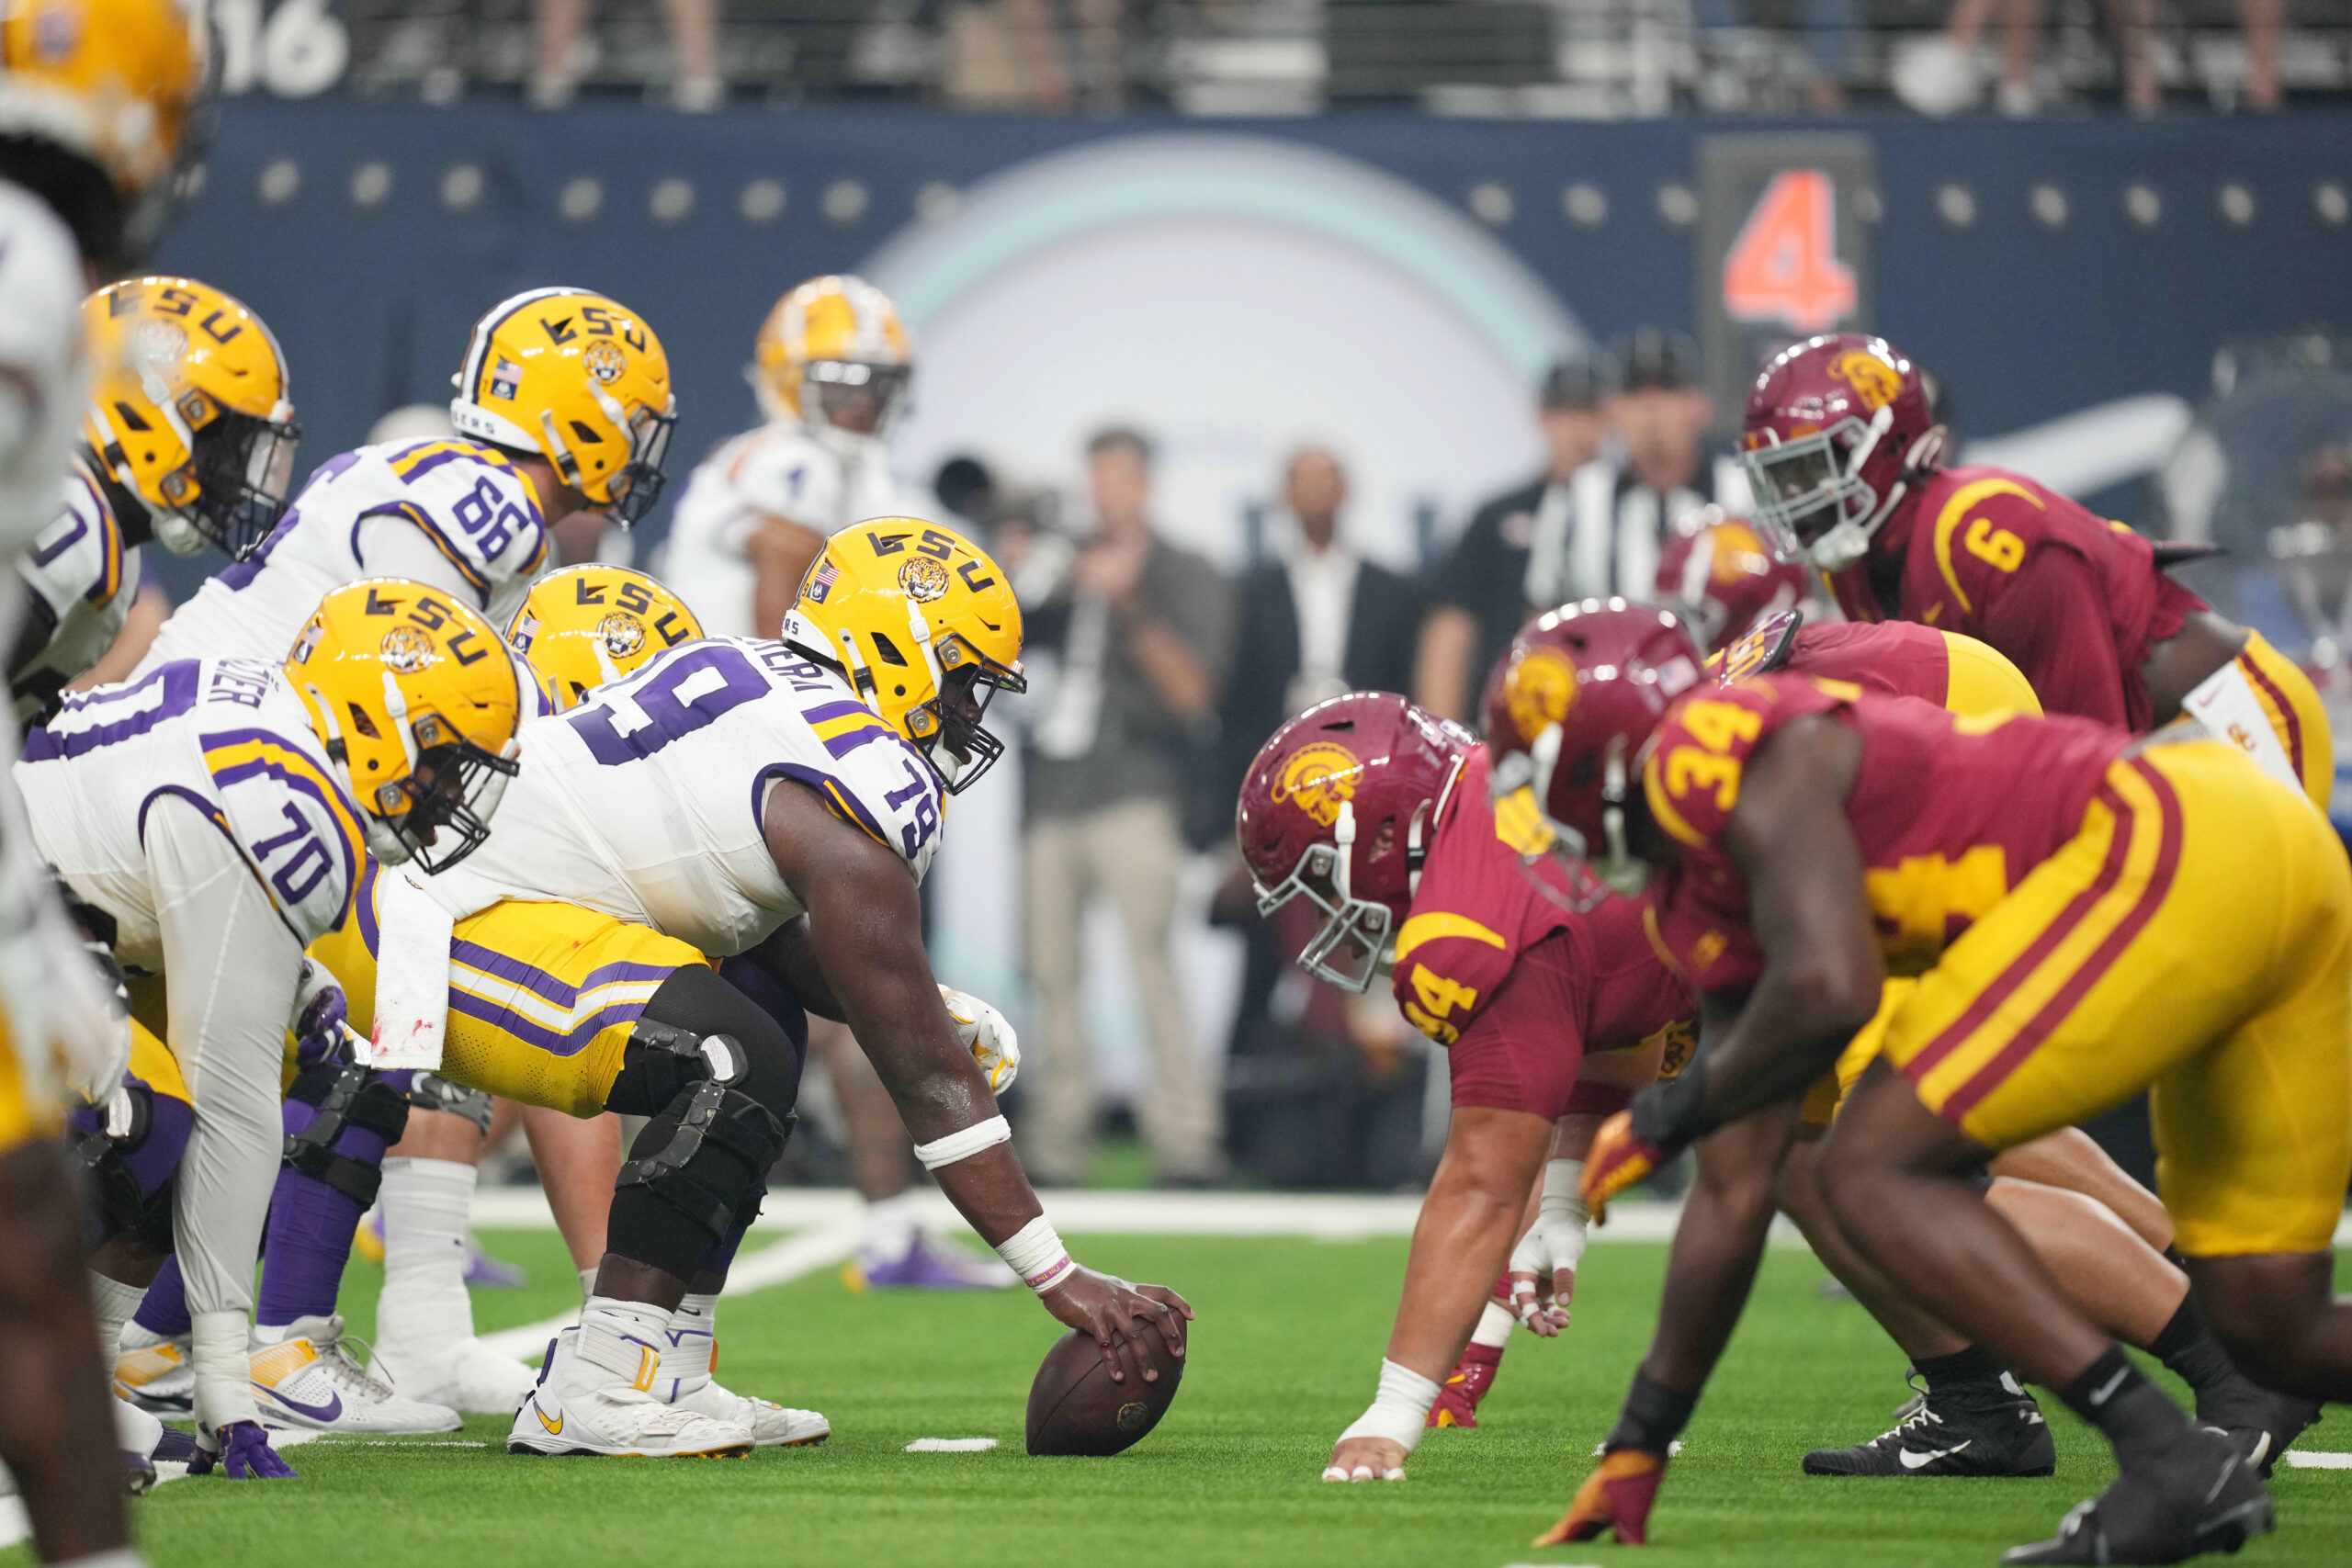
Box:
318 517 1190 1455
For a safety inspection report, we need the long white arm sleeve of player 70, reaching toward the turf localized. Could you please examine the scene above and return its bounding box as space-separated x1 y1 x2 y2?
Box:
146 797 301 1432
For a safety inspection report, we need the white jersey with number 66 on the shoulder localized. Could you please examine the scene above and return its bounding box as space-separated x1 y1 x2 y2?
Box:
139 440 548 674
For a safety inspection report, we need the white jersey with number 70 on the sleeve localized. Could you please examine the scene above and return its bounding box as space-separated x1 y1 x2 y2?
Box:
17 659 367 971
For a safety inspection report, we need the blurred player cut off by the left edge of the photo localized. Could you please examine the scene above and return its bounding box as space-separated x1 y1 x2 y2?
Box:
0 0 207 1563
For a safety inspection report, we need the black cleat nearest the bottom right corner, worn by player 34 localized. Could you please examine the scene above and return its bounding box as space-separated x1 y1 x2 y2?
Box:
2002 1429 2272 1563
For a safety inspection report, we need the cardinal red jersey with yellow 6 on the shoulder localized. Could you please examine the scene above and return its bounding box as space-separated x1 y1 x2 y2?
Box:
1830 468 2206 733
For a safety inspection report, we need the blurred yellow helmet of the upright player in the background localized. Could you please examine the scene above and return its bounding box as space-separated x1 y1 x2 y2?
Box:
751 275 915 434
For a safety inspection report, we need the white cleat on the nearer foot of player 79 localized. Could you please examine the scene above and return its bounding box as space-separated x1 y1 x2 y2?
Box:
505 1328 755 1460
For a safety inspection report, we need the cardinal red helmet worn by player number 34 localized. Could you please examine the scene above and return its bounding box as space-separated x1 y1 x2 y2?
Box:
1487 600 1701 912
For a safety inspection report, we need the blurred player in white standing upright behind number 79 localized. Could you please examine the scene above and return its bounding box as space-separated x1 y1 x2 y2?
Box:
661 275 1018 1291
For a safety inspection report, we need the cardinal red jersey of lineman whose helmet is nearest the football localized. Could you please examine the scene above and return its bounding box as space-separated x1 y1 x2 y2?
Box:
1395 745 1693 1117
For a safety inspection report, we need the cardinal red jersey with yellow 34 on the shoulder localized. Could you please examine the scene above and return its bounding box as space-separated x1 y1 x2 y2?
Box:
1642 674 2131 989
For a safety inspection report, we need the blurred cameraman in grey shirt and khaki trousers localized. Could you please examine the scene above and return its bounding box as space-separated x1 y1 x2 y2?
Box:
1023 430 1232 1185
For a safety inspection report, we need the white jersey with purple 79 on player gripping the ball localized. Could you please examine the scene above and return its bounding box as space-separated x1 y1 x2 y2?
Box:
421 637 944 957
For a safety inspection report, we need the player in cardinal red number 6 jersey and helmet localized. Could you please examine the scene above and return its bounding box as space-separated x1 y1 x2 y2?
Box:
1743 332 2335 811
